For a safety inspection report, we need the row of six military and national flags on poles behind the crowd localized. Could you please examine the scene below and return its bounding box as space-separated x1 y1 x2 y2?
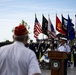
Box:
34 14 75 40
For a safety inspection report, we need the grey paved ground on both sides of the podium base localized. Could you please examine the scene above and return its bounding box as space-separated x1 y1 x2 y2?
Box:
41 65 76 75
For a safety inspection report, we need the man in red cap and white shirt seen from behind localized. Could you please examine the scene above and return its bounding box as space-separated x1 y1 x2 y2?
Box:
0 24 41 75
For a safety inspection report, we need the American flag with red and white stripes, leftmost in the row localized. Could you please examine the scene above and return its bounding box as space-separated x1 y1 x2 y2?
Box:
34 16 42 38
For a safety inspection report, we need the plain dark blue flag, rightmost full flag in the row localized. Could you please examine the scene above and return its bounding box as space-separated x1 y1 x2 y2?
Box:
66 15 75 40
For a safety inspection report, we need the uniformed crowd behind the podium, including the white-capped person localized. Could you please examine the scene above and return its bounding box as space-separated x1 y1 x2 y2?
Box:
25 37 76 75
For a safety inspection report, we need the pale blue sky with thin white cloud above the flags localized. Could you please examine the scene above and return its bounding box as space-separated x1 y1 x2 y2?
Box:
0 0 76 41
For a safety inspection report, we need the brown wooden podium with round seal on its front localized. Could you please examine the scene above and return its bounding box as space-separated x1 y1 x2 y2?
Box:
48 51 68 75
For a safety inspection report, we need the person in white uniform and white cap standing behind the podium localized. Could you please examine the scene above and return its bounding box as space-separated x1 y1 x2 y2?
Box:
58 37 71 75
